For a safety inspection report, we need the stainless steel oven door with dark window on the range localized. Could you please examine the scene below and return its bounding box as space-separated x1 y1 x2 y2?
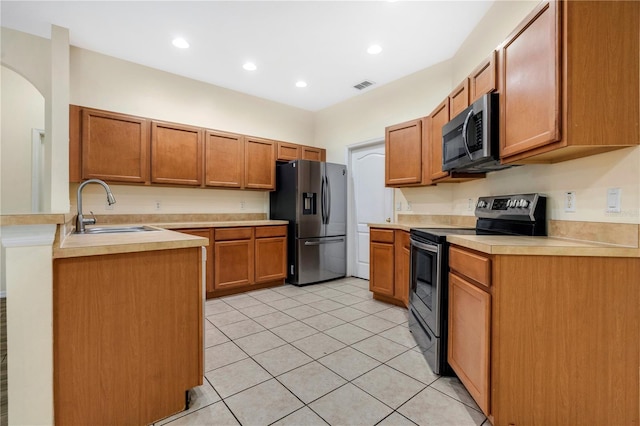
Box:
409 238 442 337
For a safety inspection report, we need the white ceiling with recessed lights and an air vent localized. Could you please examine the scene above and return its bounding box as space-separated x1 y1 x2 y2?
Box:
0 0 493 111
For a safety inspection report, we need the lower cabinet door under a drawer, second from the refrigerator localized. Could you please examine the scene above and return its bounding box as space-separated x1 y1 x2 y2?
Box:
214 238 254 290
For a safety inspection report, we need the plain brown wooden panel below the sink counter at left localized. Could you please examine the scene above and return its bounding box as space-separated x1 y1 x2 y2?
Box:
53 247 203 425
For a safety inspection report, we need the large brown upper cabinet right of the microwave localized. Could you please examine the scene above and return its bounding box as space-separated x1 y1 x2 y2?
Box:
498 1 640 163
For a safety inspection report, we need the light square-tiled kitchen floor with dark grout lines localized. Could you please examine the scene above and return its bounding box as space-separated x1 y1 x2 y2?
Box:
157 278 489 426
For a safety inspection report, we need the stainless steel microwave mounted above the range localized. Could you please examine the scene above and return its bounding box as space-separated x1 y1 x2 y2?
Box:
442 93 511 173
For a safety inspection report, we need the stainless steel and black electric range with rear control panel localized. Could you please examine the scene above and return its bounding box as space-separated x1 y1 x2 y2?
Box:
409 194 547 375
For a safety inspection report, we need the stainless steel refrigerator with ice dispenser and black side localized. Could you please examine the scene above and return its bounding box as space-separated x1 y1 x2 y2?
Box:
269 160 347 285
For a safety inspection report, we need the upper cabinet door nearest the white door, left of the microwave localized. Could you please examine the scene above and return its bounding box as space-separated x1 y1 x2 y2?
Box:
385 120 422 186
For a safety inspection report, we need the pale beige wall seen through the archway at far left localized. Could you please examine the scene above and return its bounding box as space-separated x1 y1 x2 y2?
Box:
0 66 44 214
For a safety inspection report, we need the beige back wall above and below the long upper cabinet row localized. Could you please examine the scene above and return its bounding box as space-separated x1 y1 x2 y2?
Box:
71 47 314 214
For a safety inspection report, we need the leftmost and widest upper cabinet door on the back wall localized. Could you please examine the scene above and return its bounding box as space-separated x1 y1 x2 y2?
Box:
82 108 149 183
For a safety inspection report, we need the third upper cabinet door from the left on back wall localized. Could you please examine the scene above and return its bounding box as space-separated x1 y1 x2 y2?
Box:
205 131 244 188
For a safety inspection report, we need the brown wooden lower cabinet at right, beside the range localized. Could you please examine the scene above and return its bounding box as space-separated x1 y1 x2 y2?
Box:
449 246 640 426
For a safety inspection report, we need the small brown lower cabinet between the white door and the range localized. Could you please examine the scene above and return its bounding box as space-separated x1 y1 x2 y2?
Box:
369 228 409 307
